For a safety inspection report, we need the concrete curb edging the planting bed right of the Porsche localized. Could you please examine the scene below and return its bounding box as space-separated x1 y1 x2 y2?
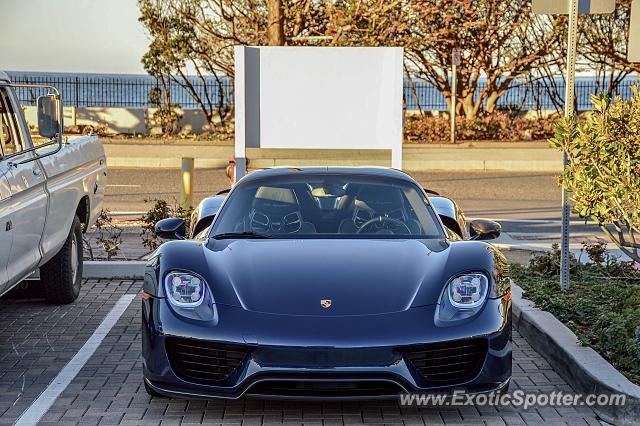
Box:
512 284 640 426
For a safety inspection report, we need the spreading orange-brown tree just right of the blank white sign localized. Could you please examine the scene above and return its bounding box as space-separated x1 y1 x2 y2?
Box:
405 0 561 118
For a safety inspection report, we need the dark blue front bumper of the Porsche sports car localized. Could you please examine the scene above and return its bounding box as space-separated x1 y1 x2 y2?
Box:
142 297 511 400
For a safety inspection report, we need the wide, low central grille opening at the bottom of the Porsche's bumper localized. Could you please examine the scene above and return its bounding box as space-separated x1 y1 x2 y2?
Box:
247 380 402 398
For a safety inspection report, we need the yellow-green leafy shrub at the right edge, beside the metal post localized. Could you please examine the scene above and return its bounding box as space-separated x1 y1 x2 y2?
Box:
550 85 640 263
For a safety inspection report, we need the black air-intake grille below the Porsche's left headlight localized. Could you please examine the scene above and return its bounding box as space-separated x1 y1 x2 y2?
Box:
165 337 249 384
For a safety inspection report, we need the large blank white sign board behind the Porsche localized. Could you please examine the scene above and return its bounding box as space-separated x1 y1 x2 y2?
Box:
236 47 404 167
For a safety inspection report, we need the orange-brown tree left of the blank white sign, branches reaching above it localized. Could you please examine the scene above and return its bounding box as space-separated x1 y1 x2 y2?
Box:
138 0 336 124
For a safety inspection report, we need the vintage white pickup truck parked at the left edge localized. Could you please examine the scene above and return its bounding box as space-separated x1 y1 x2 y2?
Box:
0 72 107 303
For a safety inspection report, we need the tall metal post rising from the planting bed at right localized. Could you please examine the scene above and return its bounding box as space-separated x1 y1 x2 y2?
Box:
560 0 578 291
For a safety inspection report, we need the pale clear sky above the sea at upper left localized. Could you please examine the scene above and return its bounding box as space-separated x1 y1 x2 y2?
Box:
0 0 149 74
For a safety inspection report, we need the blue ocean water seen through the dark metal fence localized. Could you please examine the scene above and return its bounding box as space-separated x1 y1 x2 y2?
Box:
8 72 637 111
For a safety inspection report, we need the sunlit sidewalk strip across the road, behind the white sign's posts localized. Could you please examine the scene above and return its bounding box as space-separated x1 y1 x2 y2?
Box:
103 139 562 172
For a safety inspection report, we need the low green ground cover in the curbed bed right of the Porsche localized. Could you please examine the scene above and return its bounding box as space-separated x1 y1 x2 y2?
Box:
511 247 640 383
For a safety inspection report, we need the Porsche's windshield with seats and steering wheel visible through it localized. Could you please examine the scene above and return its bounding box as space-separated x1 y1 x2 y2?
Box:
225 182 438 235
